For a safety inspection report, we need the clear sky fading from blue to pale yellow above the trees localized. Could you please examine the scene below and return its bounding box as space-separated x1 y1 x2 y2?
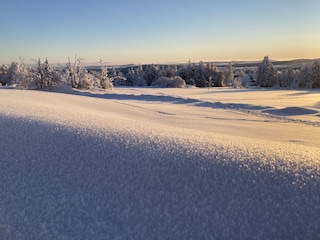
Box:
0 0 320 63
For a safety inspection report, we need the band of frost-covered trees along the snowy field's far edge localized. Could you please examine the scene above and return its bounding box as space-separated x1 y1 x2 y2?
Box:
0 56 320 90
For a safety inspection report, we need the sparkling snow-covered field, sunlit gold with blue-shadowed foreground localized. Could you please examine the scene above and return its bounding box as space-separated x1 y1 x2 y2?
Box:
0 88 320 240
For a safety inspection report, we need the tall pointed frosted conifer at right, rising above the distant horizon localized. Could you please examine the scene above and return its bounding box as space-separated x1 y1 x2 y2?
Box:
257 56 278 87
